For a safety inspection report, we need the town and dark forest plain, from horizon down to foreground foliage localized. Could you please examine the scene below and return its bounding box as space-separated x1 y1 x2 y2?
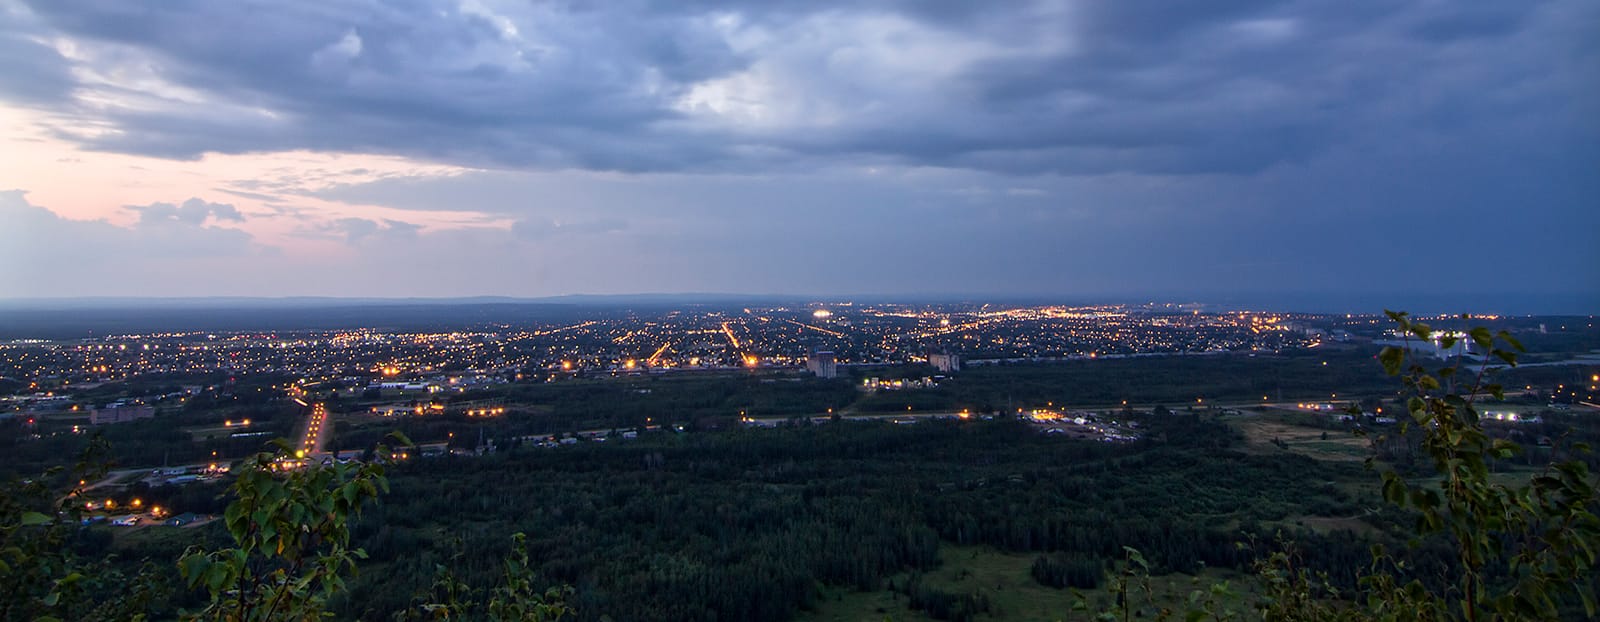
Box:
0 301 1600 620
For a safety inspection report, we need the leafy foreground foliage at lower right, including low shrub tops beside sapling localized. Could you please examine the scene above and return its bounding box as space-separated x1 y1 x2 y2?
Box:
1100 312 1600 622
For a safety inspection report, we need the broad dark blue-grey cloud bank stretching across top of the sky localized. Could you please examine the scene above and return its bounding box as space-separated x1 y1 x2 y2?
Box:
0 0 1600 174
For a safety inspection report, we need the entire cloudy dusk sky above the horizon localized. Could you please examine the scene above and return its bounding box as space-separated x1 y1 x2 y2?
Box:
0 0 1600 312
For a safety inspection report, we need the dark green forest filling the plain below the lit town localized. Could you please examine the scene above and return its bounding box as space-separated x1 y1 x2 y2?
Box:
275 416 1401 620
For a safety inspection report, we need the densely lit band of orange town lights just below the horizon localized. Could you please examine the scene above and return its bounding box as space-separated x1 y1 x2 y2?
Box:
0 302 1350 387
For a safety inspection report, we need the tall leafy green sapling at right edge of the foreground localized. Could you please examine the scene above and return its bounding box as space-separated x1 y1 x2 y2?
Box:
1368 312 1600 620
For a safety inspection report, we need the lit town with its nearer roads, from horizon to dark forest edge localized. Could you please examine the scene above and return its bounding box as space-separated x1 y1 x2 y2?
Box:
0 301 1600 520
